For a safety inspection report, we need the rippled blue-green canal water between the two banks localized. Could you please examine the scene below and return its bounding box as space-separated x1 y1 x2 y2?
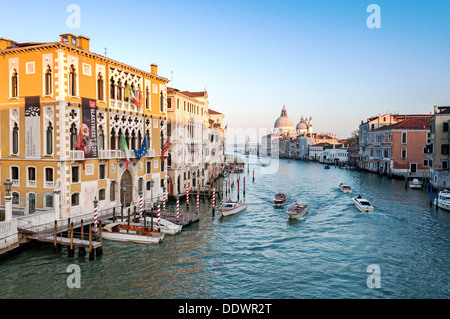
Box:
0 157 450 299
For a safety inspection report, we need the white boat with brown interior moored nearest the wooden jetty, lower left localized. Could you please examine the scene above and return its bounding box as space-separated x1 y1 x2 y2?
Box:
102 223 164 244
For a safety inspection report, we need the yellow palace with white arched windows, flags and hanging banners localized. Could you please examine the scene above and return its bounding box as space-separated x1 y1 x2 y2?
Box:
0 33 169 222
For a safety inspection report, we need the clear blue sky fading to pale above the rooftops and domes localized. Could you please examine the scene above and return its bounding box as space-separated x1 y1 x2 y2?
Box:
0 0 450 138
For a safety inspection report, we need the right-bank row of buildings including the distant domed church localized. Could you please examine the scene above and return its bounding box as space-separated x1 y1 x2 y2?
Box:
259 106 450 189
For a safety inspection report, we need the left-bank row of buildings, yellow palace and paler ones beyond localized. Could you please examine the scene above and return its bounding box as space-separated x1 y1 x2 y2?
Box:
0 33 224 253
